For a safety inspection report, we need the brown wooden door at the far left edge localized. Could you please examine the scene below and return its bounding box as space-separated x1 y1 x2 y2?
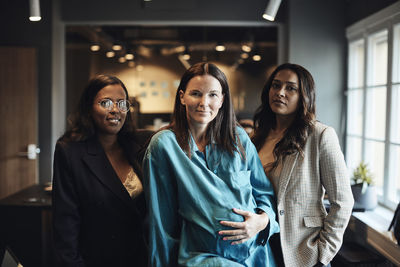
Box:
0 47 38 199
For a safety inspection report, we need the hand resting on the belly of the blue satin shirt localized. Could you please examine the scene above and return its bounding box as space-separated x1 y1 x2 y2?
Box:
218 209 269 245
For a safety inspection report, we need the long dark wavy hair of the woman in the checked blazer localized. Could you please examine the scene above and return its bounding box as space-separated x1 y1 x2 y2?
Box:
252 63 315 169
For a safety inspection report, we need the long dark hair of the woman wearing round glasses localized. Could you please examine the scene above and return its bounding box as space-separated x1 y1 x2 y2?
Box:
59 75 138 166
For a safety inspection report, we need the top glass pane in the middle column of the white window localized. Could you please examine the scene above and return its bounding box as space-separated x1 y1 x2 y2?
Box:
368 30 388 85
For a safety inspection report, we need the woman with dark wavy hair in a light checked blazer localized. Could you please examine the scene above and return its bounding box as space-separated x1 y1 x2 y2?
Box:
252 63 354 267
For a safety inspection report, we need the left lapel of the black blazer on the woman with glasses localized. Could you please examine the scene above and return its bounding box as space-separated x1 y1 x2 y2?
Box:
83 138 135 209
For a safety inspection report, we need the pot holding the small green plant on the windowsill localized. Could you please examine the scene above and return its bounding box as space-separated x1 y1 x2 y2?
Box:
351 184 378 210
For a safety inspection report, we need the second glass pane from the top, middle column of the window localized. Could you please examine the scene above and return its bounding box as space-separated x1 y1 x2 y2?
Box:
365 87 386 140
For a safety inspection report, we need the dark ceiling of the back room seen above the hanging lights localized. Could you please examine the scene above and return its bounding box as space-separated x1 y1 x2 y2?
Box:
67 26 278 70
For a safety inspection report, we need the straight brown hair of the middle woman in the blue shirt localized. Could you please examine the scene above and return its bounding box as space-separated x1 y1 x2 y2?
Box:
167 62 245 158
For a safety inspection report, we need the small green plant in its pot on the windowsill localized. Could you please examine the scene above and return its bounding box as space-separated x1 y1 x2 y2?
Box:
351 161 378 210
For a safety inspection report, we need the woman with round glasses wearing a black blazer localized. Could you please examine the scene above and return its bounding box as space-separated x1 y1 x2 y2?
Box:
53 75 147 267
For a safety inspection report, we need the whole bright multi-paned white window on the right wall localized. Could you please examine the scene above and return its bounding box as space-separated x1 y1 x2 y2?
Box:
345 3 400 208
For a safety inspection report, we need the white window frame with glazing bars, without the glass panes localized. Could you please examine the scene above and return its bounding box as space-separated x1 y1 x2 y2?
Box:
345 2 400 209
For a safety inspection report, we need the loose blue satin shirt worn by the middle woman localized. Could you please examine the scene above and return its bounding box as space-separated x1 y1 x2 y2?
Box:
143 128 279 267
